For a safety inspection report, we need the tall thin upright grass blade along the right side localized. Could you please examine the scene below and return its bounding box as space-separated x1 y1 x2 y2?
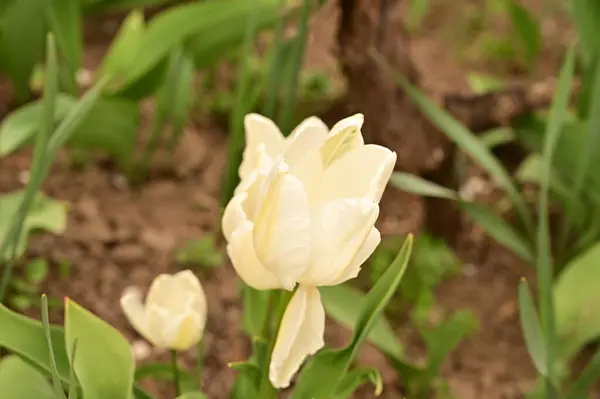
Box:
536 48 575 392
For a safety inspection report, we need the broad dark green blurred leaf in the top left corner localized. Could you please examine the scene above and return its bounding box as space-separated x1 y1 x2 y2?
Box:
0 0 47 101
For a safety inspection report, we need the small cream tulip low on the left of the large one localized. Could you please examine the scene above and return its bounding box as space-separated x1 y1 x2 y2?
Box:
121 270 207 350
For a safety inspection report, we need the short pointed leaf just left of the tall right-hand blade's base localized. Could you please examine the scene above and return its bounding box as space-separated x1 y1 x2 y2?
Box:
519 279 548 377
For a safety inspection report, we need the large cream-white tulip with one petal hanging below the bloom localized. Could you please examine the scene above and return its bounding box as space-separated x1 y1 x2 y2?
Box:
222 114 396 388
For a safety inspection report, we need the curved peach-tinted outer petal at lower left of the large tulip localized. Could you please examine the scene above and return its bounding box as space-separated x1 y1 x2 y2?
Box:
227 221 281 290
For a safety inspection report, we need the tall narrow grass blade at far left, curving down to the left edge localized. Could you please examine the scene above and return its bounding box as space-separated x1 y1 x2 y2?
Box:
0 33 58 303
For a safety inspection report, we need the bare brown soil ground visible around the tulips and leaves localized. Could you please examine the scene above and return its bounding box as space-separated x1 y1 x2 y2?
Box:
0 1 592 399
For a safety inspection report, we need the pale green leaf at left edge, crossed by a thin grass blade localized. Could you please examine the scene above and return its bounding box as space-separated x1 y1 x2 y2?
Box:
0 190 67 260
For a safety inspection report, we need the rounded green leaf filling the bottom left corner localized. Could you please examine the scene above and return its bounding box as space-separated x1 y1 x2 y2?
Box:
0 356 55 399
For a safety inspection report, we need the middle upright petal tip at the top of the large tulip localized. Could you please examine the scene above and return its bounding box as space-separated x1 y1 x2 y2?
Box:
283 117 329 168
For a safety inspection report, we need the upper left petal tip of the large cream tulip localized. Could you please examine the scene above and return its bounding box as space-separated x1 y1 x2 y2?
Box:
240 114 286 180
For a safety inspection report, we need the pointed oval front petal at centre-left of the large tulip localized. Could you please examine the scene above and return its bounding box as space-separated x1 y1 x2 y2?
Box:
254 162 310 290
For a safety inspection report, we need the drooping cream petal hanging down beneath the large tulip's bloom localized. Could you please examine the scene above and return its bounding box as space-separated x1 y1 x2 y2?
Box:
269 285 325 388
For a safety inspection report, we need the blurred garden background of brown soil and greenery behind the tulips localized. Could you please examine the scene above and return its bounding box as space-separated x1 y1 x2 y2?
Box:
0 0 600 399
